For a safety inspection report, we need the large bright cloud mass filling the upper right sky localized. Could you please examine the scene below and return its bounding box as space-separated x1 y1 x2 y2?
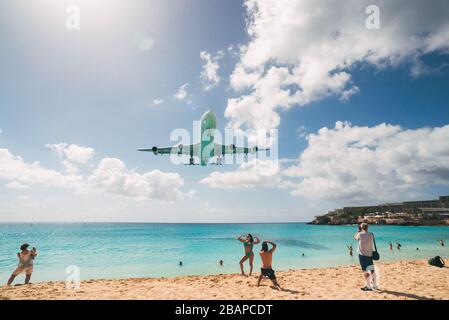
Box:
225 0 449 131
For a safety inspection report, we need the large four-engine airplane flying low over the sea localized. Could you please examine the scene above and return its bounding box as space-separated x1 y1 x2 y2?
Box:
137 111 269 166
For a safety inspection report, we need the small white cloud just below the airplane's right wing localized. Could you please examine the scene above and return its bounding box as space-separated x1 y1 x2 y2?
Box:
200 159 280 190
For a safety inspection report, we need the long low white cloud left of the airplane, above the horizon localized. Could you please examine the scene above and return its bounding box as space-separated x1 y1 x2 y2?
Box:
0 148 193 201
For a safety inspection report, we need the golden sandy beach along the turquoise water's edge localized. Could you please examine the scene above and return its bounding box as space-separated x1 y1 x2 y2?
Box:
0 259 449 300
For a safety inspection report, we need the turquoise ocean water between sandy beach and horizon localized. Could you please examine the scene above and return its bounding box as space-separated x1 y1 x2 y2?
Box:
0 223 449 283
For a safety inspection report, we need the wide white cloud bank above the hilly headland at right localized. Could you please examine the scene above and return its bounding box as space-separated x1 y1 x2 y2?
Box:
283 122 449 201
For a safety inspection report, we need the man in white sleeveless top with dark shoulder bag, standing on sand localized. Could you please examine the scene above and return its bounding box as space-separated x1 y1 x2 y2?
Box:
354 223 378 291
